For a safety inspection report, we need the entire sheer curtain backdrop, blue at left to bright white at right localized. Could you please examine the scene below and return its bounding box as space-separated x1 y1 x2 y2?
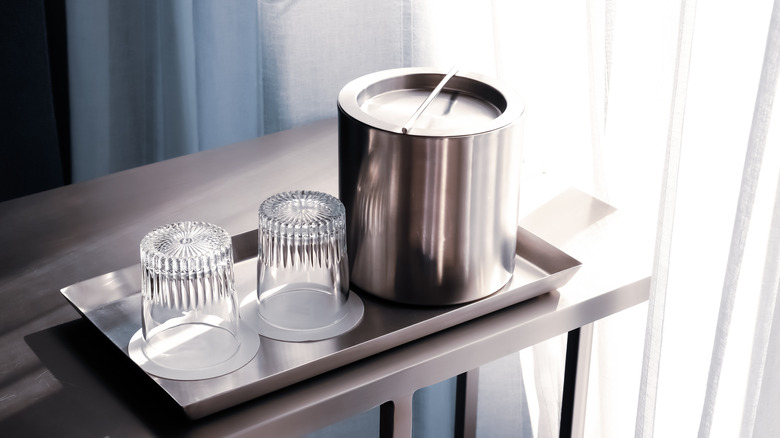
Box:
67 0 780 437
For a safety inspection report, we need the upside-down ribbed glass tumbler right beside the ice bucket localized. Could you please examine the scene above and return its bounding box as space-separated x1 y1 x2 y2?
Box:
257 190 349 331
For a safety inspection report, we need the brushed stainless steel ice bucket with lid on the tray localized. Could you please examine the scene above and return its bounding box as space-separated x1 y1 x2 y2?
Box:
338 68 524 305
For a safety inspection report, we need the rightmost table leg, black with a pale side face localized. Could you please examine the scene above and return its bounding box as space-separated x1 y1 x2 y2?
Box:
559 324 593 438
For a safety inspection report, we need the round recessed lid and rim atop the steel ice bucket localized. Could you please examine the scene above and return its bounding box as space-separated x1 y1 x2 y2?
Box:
338 67 524 137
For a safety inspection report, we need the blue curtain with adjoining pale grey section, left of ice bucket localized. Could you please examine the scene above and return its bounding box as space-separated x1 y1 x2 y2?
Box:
67 0 413 181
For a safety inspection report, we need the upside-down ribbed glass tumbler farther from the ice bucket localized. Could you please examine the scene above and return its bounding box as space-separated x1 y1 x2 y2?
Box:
141 222 240 370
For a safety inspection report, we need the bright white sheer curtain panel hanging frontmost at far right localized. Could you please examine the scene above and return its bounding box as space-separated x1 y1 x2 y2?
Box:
636 1 780 437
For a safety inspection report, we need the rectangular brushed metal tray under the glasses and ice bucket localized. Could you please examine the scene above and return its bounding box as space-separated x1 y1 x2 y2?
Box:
61 228 581 419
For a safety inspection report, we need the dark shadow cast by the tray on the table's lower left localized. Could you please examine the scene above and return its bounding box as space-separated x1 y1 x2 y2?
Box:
7 318 196 438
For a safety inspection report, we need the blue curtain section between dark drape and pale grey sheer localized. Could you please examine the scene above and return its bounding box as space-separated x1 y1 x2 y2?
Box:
67 0 262 182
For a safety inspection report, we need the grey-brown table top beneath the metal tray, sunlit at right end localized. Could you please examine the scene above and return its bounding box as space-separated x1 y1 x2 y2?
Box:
0 119 652 437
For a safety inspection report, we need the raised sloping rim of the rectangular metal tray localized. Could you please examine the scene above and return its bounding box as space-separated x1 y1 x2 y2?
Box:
60 226 582 419
